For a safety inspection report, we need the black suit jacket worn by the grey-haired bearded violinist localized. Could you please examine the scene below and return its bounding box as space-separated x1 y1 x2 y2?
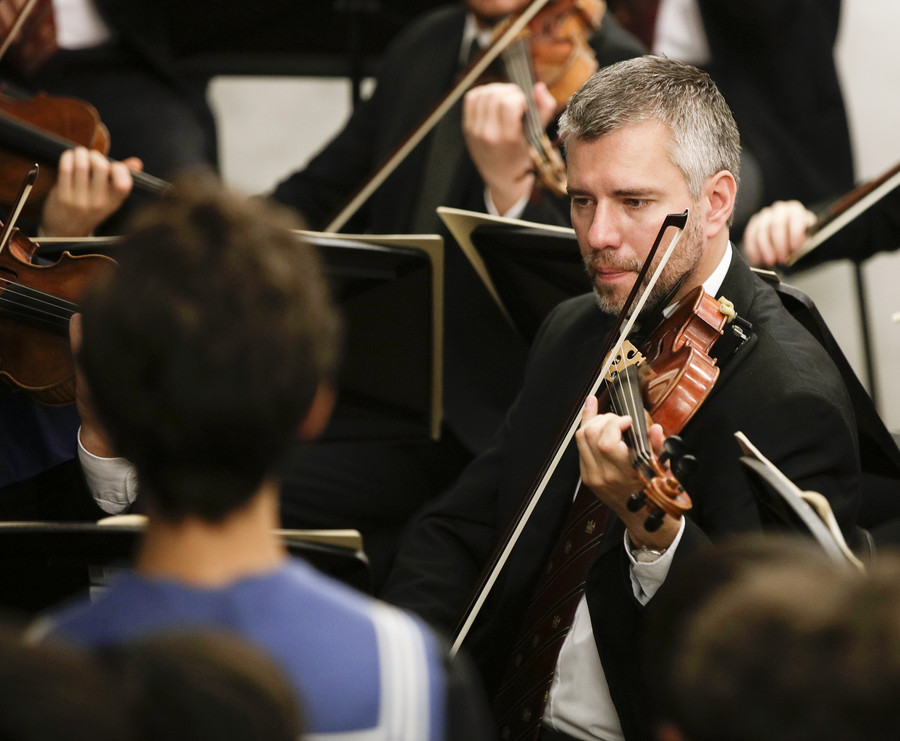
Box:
384 254 859 739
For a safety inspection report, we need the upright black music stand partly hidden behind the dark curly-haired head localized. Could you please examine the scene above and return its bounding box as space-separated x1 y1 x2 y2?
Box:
39 232 444 441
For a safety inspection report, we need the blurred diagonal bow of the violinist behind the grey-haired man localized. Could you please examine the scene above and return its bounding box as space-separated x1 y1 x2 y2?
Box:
324 0 550 232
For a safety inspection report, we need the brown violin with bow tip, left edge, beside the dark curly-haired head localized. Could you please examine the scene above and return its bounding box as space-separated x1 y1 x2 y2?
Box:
0 170 116 406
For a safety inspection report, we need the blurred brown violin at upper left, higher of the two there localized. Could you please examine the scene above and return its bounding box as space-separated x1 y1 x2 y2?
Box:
0 93 171 211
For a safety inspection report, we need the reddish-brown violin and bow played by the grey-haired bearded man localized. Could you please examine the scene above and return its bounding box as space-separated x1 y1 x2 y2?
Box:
451 211 748 653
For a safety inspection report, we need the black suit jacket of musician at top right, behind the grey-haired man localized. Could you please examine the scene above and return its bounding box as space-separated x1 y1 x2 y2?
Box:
699 0 853 204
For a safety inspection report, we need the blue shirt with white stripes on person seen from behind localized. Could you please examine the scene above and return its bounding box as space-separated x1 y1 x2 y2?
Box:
41 560 446 741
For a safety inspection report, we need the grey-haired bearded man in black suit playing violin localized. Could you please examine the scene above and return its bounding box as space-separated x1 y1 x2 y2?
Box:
383 57 860 741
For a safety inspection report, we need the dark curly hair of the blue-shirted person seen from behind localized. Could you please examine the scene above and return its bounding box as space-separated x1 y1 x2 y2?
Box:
80 177 339 522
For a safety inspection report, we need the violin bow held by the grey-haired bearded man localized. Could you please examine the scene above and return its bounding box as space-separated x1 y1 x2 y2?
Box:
450 209 688 656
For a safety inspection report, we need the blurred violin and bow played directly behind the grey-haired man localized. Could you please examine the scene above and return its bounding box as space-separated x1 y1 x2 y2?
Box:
324 0 605 232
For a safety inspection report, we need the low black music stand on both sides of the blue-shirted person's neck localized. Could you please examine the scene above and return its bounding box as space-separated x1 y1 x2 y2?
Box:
0 522 371 616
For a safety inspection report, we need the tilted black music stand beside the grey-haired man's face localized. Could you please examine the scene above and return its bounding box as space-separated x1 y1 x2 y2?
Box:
438 202 591 342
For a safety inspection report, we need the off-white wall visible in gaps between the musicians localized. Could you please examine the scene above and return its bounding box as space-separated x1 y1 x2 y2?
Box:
211 0 900 430
